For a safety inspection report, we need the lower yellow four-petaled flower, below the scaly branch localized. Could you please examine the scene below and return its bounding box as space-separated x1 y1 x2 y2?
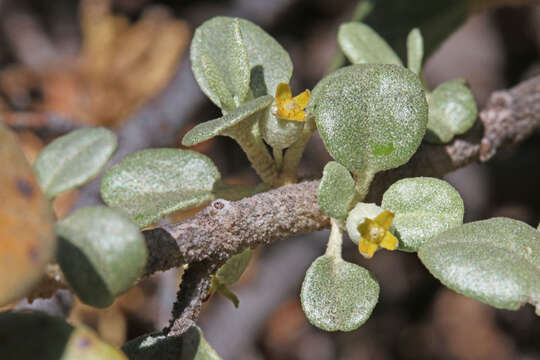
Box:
358 210 398 259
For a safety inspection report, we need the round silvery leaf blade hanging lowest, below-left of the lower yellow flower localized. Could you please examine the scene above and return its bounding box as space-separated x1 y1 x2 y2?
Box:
300 255 379 331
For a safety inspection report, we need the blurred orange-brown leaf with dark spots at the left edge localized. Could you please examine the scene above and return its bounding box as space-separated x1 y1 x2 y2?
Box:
0 123 56 305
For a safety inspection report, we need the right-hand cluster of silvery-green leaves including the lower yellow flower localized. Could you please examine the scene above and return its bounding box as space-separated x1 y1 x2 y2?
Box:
310 22 540 331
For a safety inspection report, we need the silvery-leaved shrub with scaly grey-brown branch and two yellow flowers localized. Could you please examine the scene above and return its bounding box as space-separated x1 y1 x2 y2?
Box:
0 1 540 359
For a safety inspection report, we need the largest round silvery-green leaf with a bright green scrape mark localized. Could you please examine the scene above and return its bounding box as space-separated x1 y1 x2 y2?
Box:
311 64 428 172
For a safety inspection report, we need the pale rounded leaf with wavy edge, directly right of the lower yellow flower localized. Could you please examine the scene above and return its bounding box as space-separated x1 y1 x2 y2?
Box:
381 177 465 251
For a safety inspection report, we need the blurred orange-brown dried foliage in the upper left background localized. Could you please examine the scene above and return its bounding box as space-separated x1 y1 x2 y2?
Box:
0 0 190 126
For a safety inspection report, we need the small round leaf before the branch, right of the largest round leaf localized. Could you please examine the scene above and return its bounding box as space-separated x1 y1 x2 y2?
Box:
426 79 477 143
